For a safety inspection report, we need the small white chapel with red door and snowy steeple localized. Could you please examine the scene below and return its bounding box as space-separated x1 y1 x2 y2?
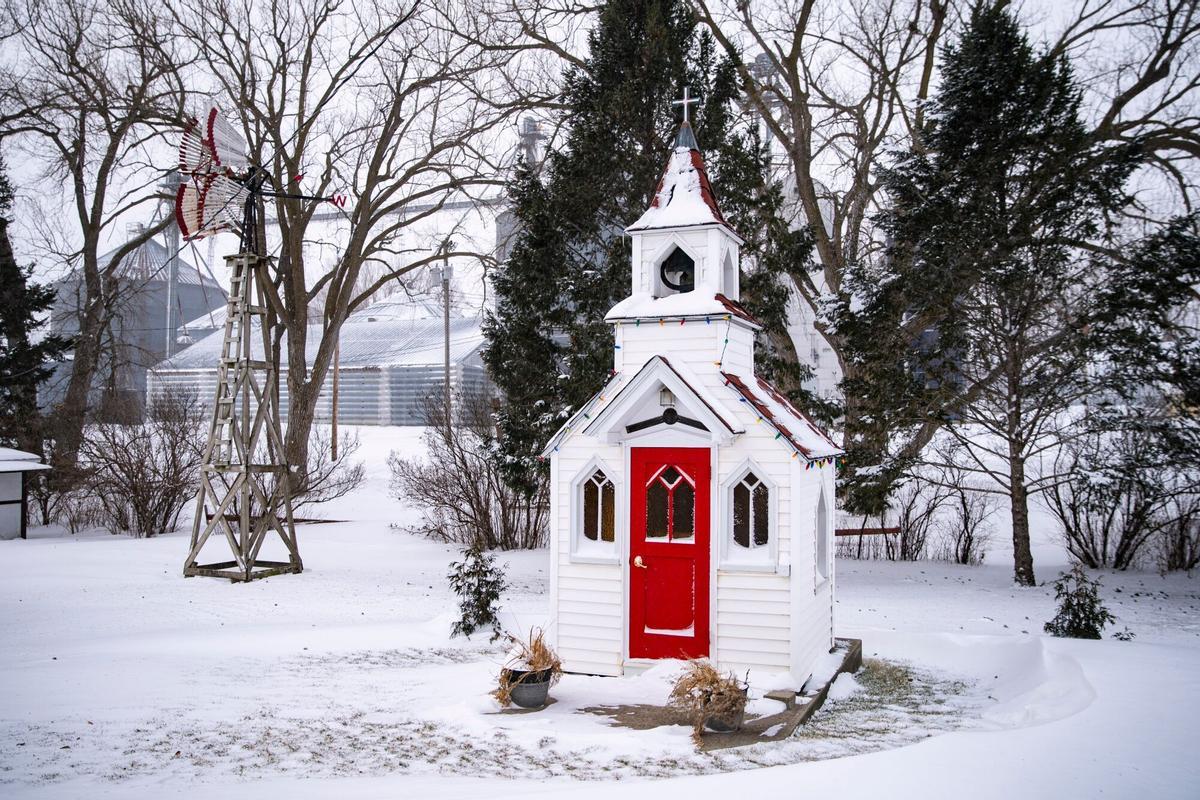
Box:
544 104 842 688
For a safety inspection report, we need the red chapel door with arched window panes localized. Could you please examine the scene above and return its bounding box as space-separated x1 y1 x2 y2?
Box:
629 447 709 658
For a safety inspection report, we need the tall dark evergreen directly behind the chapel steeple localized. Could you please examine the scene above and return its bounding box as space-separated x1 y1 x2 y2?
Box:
485 0 809 493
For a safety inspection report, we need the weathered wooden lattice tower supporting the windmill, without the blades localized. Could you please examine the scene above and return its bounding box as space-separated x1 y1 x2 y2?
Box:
184 250 304 581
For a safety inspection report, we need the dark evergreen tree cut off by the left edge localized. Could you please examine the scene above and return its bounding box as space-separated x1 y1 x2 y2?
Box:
0 157 68 455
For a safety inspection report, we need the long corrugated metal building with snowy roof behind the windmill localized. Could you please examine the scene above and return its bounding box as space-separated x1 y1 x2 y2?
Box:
148 302 491 425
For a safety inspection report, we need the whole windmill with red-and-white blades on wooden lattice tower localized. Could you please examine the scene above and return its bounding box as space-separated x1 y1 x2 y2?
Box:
175 108 344 581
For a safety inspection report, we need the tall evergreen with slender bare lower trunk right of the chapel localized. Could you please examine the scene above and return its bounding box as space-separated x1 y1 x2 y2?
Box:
846 2 1139 585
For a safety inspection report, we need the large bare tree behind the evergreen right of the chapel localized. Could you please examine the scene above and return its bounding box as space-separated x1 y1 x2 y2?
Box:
695 0 1200 491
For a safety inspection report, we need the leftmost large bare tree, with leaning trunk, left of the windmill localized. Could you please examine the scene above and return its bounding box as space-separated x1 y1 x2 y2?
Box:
0 0 184 473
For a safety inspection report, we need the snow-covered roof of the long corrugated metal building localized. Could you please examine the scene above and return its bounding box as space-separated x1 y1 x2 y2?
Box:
154 315 484 372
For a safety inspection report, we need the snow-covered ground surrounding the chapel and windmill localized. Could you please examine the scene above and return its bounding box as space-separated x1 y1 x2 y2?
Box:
0 428 1200 799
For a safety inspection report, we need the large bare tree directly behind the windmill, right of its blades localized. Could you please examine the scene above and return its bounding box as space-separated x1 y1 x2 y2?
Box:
179 0 535 484
